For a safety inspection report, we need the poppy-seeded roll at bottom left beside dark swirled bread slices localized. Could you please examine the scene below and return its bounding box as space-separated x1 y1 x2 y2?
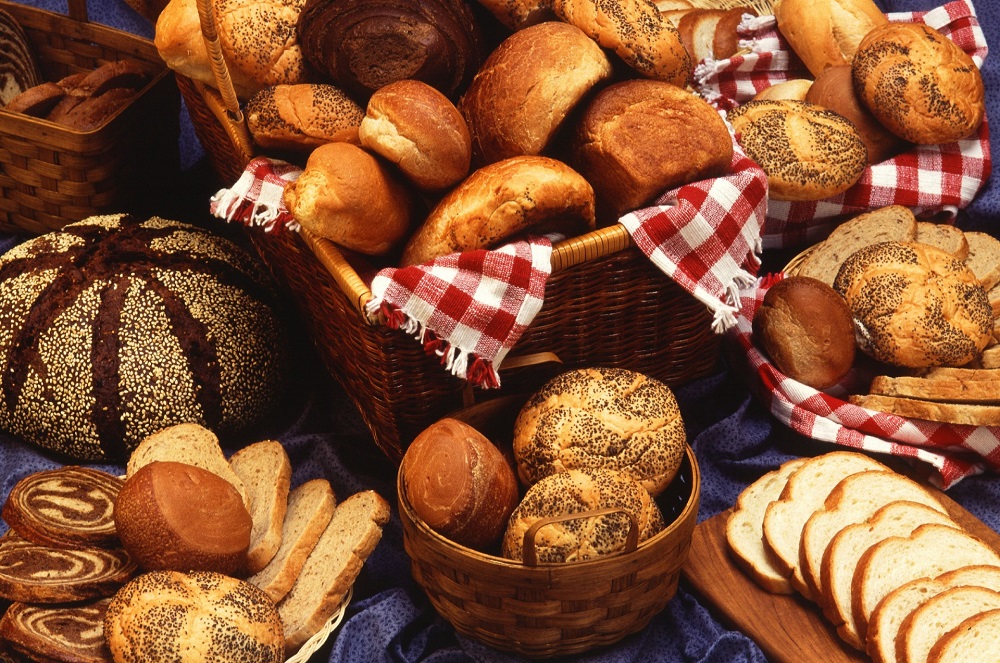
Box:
104 571 285 663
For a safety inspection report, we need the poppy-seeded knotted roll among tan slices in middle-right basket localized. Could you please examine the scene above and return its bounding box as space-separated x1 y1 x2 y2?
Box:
833 242 993 368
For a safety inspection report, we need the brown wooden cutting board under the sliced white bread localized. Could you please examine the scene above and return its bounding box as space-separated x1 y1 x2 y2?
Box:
681 489 1000 663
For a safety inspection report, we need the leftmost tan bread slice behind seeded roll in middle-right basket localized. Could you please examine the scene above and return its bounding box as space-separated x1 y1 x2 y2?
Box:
795 205 917 286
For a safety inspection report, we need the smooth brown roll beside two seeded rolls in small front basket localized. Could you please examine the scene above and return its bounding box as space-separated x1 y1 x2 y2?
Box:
399 417 520 551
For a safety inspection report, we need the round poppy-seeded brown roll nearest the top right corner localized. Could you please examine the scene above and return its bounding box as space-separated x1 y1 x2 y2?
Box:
852 23 986 145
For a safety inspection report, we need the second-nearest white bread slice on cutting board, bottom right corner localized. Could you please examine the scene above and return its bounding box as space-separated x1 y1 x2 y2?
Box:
896 587 1000 663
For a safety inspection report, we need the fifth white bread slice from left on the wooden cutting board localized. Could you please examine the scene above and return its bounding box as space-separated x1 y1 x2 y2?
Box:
851 523 1000 637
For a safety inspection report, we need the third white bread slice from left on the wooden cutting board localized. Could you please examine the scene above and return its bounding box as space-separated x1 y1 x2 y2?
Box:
799 470 947 600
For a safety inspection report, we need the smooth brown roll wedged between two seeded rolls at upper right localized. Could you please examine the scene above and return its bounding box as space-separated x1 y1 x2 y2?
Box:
805 64 909 163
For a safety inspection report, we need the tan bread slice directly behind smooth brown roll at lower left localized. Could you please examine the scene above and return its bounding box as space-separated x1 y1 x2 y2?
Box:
125 423 253 511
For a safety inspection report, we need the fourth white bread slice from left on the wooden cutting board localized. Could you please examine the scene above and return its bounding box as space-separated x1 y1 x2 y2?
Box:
820 501 959 651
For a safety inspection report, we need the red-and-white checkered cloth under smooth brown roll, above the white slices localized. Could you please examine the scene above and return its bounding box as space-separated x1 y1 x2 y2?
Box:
729 274 1000 489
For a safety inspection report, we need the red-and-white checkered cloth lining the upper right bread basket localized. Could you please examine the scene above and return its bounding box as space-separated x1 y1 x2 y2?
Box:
695 0 991 249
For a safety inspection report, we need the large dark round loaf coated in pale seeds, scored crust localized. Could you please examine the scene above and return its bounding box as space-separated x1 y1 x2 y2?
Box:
0 215 287 461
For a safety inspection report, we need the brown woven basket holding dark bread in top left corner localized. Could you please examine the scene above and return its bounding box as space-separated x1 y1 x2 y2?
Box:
0 0 180 234
